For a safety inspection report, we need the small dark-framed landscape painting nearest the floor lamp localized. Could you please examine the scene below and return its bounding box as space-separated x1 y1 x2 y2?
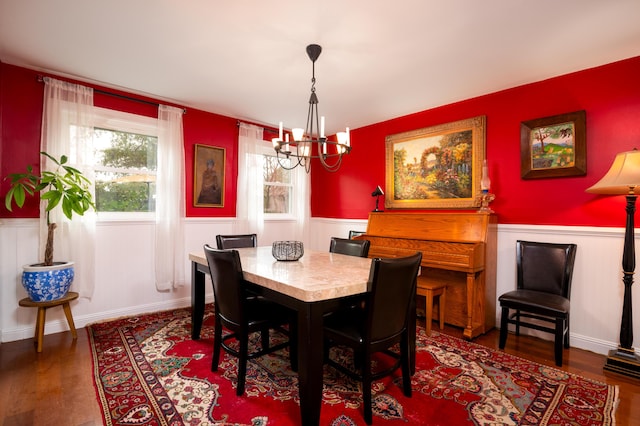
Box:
520 111 587 179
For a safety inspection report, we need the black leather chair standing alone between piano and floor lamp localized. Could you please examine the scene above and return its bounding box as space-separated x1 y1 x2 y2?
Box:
498 240 577 366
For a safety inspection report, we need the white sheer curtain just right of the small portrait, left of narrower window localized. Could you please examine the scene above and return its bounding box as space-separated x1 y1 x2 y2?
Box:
234 123 264 236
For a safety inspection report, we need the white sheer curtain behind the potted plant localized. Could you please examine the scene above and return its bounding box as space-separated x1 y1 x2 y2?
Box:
39 77 96 298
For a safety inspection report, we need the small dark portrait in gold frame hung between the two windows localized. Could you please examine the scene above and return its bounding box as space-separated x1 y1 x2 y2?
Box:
193 144 225 207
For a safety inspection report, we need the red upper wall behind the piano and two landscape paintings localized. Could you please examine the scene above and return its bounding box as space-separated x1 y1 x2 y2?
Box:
311 57 640 227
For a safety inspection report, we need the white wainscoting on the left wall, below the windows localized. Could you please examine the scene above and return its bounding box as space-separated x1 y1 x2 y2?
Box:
0 218 308 342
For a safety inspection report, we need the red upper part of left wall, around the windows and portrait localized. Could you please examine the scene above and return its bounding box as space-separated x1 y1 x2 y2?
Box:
0 63 238 217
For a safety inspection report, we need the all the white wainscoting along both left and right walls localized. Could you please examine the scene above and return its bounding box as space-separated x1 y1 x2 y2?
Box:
0 218 640 354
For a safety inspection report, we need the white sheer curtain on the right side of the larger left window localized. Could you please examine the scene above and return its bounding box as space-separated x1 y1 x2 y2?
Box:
155 105 187 291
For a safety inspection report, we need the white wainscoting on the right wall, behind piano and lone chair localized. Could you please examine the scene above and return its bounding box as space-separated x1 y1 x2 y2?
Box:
312 218 640 354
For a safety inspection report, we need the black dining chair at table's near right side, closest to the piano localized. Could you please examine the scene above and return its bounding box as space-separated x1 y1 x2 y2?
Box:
324 252 422 424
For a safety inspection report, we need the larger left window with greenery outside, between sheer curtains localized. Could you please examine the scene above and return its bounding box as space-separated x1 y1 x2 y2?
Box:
89 108 158 213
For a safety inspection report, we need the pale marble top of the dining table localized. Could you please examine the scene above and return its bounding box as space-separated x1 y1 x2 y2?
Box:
189 246 371 302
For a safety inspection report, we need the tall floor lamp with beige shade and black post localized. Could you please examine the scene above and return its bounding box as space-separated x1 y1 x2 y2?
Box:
586 149 640 378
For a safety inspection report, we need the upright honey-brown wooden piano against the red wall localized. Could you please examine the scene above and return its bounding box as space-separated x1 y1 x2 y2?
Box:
355 212 497 339
